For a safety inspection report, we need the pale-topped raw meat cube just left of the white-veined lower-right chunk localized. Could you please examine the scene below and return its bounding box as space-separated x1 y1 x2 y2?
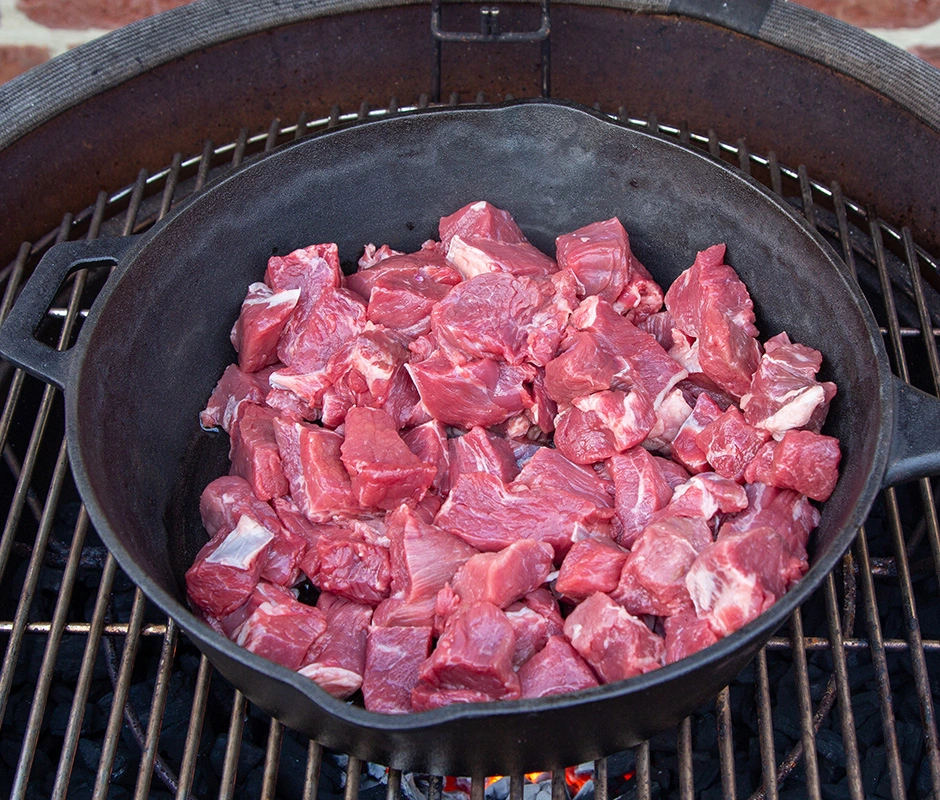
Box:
610 517 712 617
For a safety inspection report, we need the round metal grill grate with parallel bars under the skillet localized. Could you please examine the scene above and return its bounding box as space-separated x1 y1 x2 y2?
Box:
0 98 940 800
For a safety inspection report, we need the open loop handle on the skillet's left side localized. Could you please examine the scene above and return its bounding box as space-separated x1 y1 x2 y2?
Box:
0 236 137 388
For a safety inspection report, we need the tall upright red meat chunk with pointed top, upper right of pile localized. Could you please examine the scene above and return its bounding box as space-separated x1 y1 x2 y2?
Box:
665 245 761 399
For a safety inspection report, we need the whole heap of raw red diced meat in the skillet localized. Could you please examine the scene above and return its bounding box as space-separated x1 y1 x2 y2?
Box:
187 202 840 713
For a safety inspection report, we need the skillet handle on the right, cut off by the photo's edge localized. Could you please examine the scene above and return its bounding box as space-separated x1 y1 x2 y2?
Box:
881 377 940 487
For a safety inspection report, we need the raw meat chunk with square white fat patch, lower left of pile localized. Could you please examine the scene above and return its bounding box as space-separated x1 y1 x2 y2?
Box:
186 516 274 619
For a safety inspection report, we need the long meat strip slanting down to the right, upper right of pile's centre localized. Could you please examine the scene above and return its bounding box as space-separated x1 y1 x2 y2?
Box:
569 297 687 408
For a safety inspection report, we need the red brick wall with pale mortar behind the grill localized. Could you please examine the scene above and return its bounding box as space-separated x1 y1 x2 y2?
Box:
0 0 940 83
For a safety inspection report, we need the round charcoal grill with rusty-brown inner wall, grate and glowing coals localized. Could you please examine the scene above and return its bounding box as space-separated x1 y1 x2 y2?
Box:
0 0 940 800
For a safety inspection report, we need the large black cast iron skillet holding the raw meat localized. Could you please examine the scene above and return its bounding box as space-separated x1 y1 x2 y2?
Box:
0 101 940 775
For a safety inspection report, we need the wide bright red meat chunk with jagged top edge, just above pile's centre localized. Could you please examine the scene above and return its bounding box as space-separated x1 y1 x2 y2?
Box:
406 353 533 429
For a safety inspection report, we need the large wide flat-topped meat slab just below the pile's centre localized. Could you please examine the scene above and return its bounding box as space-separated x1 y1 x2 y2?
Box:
434 472 597 558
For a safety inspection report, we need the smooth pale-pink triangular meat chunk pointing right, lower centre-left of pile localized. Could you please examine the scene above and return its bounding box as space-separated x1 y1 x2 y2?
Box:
388 506 477 615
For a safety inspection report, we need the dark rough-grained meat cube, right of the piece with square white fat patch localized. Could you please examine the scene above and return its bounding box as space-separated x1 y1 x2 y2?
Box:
310 536 392 606
